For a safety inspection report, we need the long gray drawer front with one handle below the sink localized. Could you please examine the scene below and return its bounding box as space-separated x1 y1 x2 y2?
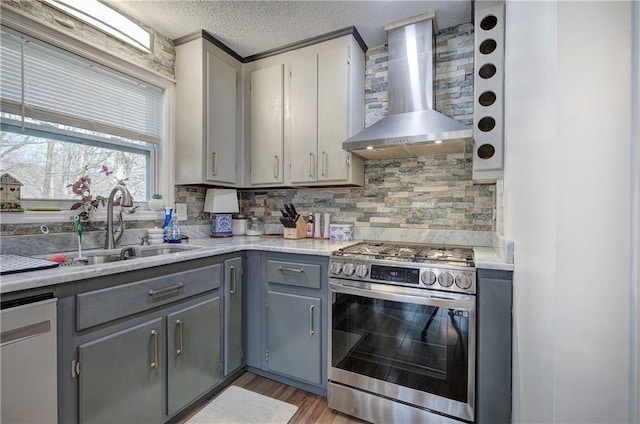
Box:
76 264 222 331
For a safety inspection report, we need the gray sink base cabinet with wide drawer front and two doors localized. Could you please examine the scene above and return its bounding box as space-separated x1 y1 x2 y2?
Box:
58 258 228 423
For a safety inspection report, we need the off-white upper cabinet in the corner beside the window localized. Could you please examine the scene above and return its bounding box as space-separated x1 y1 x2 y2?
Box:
175 38 241 186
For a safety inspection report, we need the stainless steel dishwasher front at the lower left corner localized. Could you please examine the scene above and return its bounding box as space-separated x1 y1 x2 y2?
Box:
0 299 58 423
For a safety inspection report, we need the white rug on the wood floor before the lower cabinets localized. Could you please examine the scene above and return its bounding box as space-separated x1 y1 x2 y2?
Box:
186 386 298 424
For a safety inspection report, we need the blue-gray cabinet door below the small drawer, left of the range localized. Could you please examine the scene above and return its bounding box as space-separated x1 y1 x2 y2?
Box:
267 291 322 384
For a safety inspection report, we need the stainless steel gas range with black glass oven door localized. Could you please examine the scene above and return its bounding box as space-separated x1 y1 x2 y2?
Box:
327 241 476 423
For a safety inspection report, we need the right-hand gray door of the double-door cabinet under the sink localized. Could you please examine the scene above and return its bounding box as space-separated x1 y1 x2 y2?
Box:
167 297 222 415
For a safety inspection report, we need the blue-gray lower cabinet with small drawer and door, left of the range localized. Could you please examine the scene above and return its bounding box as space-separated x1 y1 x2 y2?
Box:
258 253 328 394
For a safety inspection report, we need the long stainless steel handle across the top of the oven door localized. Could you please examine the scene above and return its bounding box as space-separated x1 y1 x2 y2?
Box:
329 280 476 310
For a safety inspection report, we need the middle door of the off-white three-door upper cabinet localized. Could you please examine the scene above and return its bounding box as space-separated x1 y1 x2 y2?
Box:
288 54 318 183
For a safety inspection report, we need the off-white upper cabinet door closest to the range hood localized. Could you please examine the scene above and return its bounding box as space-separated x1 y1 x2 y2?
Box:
318 46 352 181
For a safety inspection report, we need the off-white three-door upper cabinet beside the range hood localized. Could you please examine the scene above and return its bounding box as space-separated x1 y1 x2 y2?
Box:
248 35 365 186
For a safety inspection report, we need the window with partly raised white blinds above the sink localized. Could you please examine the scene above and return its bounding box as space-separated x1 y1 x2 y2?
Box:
0 32 163 205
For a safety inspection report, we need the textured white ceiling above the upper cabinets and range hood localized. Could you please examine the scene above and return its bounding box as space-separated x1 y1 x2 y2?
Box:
106 0 472 57
